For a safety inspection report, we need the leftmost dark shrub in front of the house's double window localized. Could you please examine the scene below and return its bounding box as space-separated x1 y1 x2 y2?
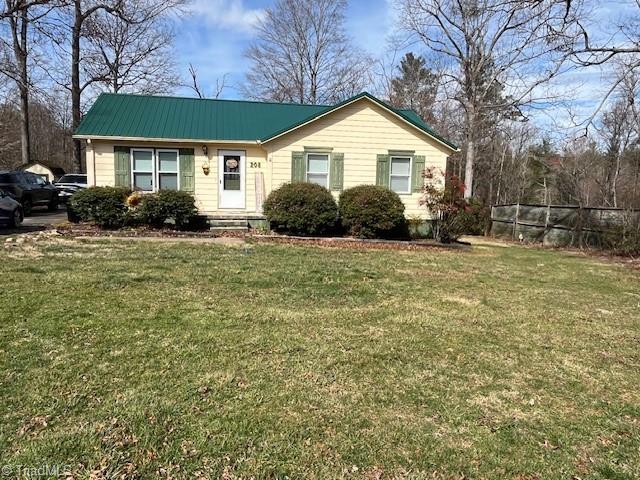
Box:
69 187 131 228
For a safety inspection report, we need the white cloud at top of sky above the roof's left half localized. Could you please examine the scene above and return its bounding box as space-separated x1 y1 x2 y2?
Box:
190 0 265 33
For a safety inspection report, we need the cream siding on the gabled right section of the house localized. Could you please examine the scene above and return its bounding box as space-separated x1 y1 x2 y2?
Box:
264 99 449 218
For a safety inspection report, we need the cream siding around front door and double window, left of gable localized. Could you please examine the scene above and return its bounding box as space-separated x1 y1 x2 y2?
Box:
87 140 270 215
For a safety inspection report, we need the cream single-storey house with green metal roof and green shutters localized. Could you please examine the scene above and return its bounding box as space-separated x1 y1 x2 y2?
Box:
74 93 457 227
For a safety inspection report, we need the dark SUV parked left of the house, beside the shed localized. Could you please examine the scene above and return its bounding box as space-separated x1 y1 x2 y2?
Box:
0 171 58 215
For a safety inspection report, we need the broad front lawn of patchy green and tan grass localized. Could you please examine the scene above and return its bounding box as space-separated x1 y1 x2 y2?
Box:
0 241 640 479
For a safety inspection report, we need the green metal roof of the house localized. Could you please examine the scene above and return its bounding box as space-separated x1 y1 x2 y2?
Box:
75 93 457 149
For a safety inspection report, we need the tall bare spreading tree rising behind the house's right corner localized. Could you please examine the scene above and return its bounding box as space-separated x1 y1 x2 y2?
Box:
401 0 575 197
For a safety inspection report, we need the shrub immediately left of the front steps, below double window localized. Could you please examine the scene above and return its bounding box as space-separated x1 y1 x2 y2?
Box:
136 190 198 229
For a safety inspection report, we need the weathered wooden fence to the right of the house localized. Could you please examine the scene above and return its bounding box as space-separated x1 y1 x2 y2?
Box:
491 203 640 247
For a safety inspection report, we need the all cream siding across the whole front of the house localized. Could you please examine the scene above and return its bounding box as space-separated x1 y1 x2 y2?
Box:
87 98 450 218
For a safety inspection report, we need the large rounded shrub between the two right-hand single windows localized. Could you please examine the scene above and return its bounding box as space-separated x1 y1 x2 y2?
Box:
339 185 408 238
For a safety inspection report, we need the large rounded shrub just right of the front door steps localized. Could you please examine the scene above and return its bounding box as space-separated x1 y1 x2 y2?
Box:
263 183 338 236
